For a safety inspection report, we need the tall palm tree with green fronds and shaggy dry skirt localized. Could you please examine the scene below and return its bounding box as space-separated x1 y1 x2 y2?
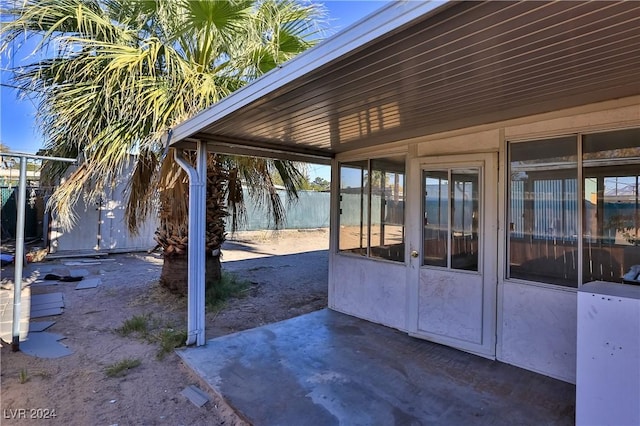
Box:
0 0 323 291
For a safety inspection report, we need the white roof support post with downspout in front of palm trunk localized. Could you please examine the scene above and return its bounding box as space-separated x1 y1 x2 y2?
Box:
172 140 207 346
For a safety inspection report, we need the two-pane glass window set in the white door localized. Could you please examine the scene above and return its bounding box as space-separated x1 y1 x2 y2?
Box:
422 168 480 271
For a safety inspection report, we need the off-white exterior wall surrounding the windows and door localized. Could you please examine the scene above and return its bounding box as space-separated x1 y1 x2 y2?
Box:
329 96 640 383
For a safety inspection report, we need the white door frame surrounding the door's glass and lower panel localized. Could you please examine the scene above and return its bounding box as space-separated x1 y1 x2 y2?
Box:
406 152 500 359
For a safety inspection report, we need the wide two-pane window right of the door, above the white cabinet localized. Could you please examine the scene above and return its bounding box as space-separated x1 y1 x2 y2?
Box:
507 129 640 287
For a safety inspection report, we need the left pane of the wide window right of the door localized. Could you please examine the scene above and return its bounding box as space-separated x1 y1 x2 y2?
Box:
509 137 578 287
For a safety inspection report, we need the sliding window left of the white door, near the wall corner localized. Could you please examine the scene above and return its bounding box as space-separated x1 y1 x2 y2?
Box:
338 157 405 262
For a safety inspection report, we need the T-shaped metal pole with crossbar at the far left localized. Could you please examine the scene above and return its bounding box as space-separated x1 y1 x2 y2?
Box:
2 152 76 352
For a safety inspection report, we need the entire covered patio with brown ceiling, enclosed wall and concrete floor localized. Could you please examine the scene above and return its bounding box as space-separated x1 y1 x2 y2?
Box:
166 1 640 424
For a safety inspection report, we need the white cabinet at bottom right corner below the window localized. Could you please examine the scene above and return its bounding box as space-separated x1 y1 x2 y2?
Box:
576 281 640 426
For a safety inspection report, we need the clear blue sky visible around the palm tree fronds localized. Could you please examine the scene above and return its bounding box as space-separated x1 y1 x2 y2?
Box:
0 0 387 180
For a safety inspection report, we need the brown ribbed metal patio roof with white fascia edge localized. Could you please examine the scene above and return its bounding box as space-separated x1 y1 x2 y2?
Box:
171 1 640 161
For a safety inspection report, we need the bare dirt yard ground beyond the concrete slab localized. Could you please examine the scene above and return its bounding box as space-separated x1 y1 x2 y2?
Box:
0 230 328 425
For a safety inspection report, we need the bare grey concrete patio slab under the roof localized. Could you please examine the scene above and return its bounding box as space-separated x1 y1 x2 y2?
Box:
178 309 575 426
